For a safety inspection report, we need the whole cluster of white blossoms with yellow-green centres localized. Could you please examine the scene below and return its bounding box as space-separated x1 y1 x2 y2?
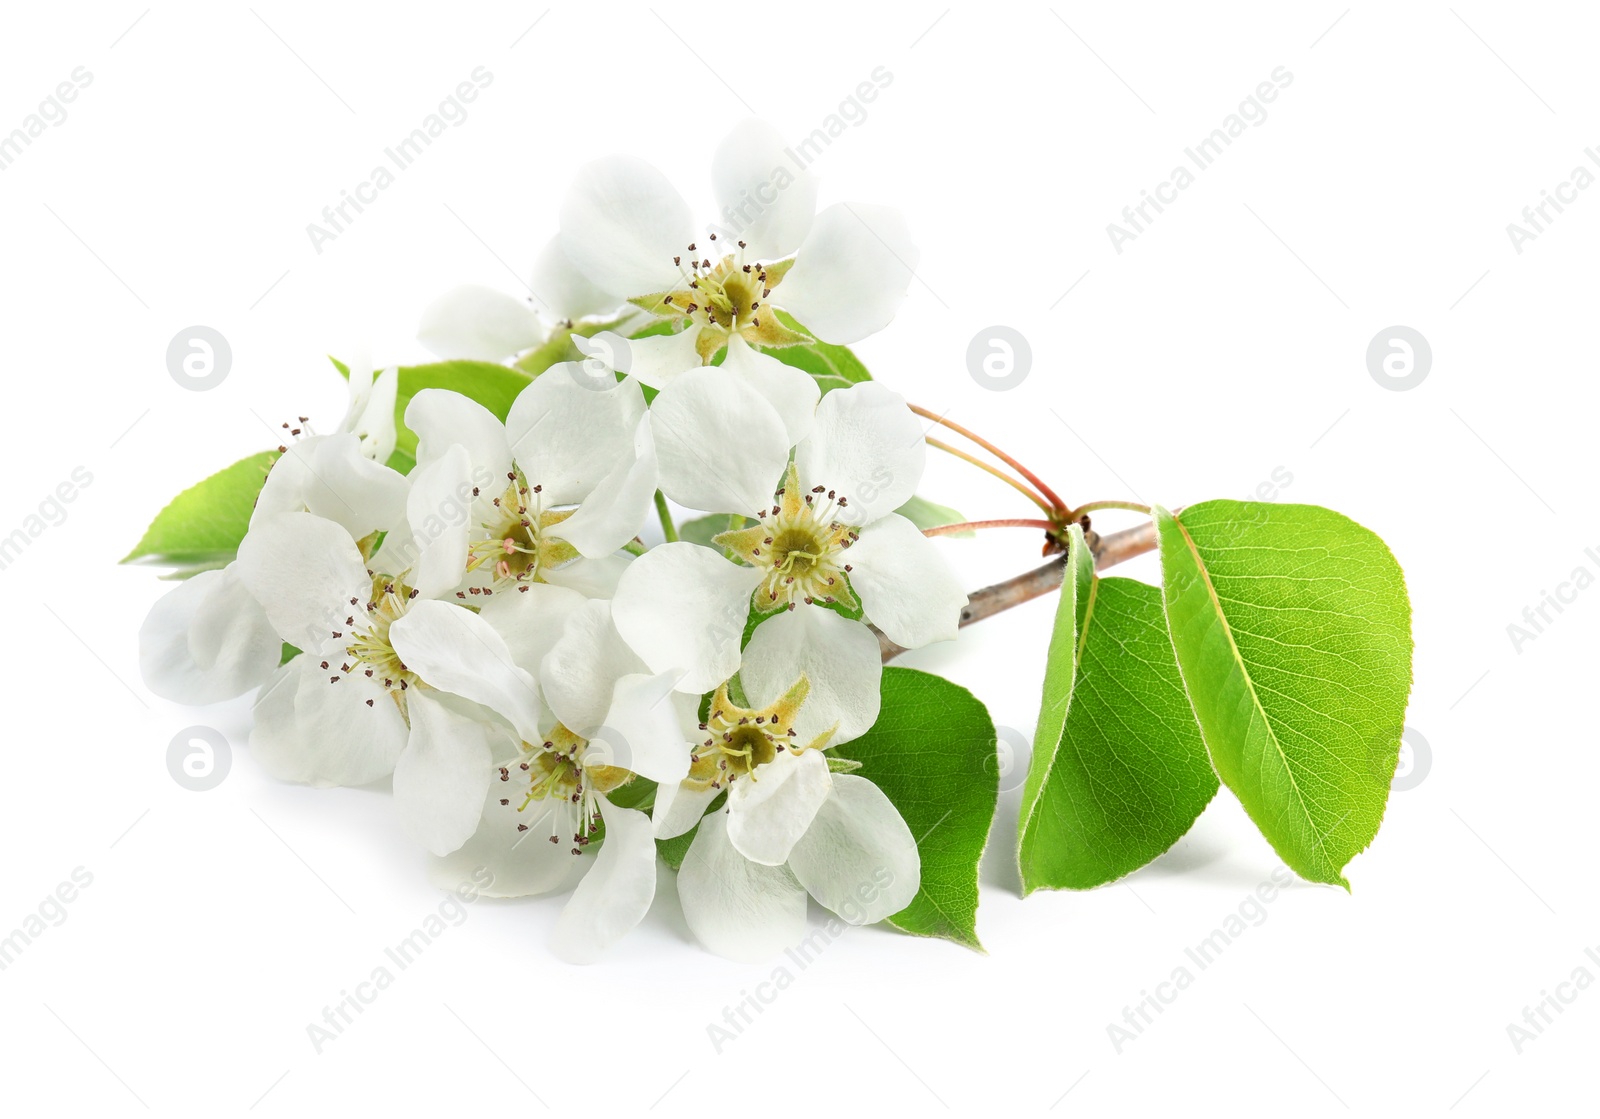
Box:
141 122 966 961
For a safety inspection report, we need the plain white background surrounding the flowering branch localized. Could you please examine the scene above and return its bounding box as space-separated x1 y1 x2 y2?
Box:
0 0 1600 1116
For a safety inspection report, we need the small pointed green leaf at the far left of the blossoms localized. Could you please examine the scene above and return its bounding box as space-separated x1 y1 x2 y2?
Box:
122 451 278 563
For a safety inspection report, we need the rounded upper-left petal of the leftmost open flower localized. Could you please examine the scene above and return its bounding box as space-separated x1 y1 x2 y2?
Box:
235 512 373 652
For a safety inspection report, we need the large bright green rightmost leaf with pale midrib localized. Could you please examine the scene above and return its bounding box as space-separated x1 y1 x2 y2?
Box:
1155 501 1411 888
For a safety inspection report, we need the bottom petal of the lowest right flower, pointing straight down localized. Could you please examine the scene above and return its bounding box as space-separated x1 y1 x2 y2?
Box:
678 812 805 964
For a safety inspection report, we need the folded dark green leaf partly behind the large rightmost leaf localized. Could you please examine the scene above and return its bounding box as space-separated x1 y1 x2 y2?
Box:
1018 525 1218 896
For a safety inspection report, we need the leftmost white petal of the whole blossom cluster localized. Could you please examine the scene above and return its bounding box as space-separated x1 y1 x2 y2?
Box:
139 564 283 706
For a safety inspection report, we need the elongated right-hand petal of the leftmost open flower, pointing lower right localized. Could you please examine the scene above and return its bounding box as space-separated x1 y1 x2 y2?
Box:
389 599 541 743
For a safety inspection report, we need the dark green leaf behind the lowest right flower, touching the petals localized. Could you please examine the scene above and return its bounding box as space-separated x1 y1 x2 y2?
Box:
845 668 1000 951
